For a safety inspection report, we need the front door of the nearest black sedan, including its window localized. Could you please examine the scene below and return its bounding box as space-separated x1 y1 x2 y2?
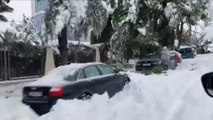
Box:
97 65 125 97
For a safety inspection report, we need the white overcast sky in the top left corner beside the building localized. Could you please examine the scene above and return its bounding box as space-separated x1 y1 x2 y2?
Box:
0 0 31 31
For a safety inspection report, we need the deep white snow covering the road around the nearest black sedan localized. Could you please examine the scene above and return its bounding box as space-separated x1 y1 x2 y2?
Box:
0 54 213 120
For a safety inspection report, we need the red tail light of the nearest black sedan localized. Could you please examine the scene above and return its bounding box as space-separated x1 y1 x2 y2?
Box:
49 87 64 97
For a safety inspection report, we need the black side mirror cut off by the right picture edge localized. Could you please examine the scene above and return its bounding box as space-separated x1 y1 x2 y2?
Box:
201 72 213 97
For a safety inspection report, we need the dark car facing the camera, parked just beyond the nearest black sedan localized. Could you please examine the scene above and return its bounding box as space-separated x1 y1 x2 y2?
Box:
135 52 177 72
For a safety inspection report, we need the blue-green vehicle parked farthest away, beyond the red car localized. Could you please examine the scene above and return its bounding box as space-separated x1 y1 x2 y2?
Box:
179 46 196 59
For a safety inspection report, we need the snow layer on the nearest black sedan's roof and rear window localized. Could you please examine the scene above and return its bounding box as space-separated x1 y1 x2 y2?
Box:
30 62 103 86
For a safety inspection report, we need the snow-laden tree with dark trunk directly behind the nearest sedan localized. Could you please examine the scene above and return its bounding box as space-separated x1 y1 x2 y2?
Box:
45 0 88 65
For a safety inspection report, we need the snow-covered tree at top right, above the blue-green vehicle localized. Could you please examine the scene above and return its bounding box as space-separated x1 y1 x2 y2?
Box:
164 0 209 44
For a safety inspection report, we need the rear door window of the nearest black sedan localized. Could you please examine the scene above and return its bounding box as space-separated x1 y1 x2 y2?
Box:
84 66 101 78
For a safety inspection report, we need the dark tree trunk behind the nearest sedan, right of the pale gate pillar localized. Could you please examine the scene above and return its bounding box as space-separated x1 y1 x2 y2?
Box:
58 26 68 65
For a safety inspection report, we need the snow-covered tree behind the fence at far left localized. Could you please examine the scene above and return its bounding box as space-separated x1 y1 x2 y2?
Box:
4 15 40 45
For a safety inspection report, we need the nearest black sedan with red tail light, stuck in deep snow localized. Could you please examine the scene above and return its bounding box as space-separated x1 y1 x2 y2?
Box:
22 63 130 115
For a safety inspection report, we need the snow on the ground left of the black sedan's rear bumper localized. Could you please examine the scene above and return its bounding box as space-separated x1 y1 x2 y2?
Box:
0 83 38 120
